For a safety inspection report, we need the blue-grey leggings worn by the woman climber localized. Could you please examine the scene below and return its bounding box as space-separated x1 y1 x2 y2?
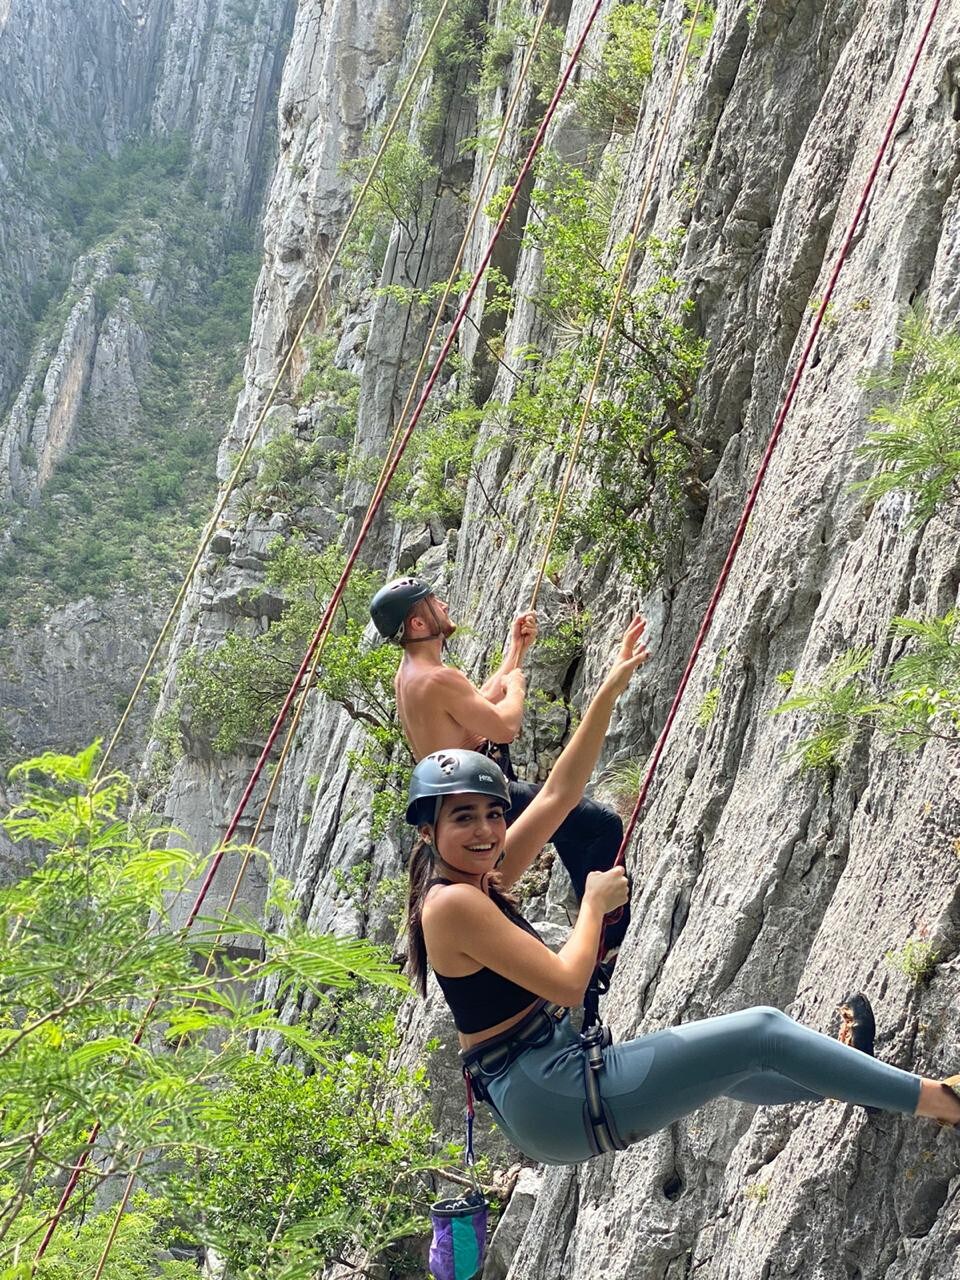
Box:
485 1006 920 1165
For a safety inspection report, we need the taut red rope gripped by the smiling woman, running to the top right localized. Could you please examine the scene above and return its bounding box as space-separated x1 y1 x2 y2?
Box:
608 0 941 885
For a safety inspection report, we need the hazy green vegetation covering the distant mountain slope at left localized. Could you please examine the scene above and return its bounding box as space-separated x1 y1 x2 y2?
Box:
0 137 259 622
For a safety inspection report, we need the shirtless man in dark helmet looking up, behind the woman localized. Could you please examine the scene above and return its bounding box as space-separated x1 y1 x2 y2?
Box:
370 577 630 961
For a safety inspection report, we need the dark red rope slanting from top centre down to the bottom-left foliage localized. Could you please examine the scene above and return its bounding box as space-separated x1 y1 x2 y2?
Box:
35 0 604 1262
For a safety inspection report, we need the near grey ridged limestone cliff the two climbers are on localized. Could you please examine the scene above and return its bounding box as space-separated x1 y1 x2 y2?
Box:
58 0 960 1280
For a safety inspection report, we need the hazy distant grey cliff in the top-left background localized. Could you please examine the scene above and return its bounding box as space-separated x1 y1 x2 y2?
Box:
0 0 293 819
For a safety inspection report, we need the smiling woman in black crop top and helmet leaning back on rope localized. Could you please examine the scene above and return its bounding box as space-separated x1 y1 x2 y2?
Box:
407 618 960 1165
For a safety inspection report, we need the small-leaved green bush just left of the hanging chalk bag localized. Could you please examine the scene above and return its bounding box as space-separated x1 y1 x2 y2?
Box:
173 988 449 1277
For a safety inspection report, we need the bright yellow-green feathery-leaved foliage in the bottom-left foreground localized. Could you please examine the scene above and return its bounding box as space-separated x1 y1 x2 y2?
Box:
0 745 406 1259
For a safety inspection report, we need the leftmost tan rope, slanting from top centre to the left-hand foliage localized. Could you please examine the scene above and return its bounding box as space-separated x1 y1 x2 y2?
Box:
97 0 452 781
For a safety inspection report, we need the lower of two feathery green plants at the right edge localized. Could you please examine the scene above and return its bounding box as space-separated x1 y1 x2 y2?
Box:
773 609 960 768
